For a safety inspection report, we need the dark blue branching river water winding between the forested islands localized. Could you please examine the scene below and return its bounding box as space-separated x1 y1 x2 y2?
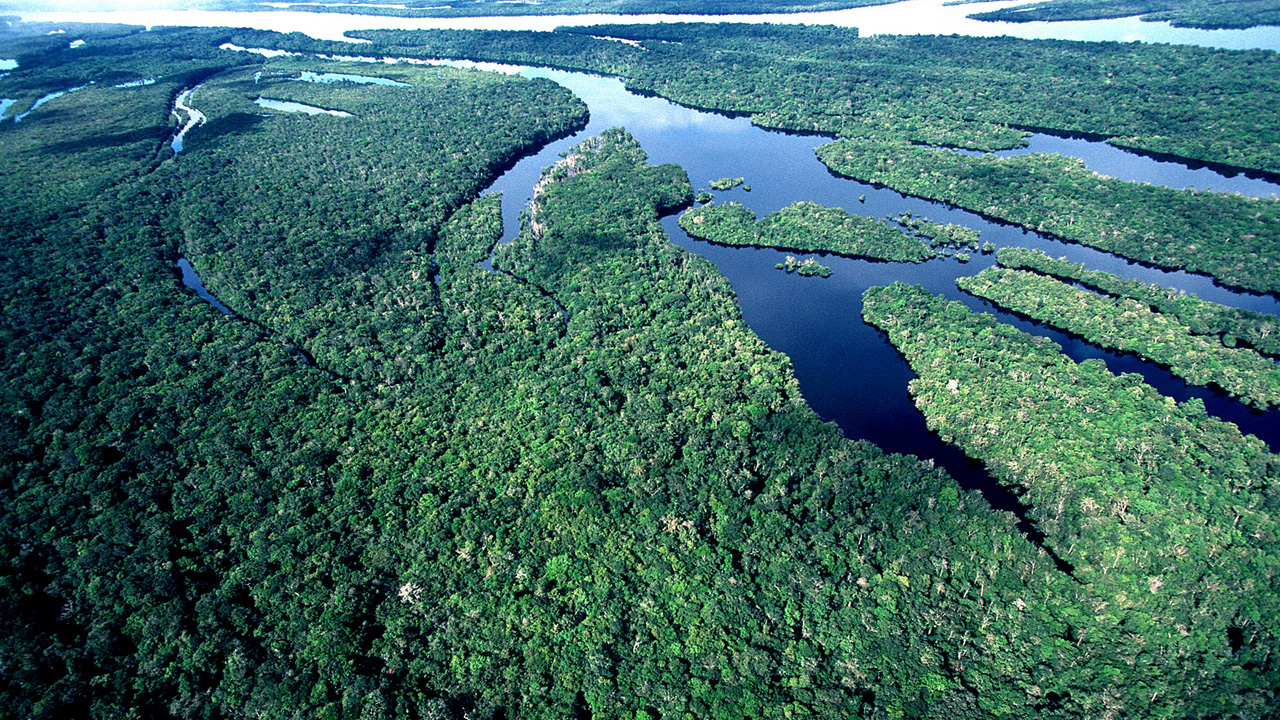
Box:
481 69 1280 486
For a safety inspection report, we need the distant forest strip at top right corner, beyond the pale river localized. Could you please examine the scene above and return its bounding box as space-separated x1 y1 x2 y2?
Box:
969 0 1280 29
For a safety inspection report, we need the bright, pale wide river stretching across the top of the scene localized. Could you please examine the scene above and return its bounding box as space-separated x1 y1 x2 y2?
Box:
19 0 1280 50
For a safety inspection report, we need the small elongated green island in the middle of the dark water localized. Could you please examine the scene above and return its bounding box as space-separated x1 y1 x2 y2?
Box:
680 201 934 263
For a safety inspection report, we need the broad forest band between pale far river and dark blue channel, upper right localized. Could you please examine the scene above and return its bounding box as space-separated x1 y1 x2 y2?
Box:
285 23 1280 173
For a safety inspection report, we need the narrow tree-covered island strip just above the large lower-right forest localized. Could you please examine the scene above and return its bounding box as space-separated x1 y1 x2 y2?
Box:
956 268 1280 410
